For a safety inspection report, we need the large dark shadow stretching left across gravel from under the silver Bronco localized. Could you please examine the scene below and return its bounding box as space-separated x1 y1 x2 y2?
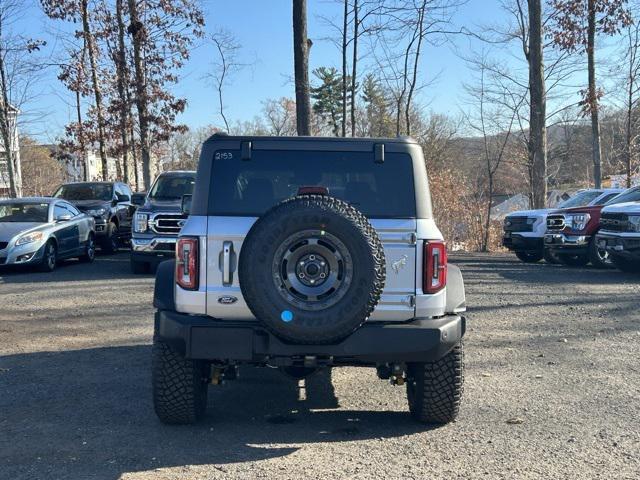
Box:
0 346 425 479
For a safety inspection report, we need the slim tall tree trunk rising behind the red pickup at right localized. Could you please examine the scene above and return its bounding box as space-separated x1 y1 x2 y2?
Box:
587 0 602 188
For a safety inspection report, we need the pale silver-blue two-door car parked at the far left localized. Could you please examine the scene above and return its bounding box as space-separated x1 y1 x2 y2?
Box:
0 197 95 272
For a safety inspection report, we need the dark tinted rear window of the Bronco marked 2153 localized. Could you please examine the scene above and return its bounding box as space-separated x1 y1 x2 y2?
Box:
209 150 416 218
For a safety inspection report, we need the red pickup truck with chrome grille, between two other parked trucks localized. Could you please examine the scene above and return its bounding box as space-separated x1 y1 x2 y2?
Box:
544 187 627 268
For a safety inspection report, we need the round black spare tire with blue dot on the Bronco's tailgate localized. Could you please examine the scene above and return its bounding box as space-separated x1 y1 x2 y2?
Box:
238 195 385 344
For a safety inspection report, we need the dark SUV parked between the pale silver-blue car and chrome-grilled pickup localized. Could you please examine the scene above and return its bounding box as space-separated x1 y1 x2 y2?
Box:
53 182 135 253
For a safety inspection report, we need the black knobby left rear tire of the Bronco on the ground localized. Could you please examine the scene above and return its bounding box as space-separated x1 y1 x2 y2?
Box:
151 337 208 425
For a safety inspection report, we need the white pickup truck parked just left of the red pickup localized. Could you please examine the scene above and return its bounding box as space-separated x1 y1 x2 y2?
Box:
502 188 623 263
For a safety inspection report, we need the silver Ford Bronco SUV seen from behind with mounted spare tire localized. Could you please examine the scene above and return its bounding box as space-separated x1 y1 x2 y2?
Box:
152 135 466 424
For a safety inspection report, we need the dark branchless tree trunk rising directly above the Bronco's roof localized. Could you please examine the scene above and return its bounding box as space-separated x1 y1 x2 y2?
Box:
292 0 311 135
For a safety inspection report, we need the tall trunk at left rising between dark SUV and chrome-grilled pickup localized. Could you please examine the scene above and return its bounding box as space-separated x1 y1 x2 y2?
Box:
128 0 151 189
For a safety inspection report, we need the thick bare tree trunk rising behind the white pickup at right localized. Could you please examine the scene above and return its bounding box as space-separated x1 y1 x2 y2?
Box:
528 0 547 208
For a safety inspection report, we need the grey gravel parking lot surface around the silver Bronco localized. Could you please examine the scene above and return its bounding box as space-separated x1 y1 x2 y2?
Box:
0 252 640 480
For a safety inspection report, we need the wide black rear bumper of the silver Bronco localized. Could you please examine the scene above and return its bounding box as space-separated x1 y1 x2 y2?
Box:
155 310 466 365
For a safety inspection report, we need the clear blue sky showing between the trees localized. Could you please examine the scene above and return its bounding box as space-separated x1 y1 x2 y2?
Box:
12 0 576 141
